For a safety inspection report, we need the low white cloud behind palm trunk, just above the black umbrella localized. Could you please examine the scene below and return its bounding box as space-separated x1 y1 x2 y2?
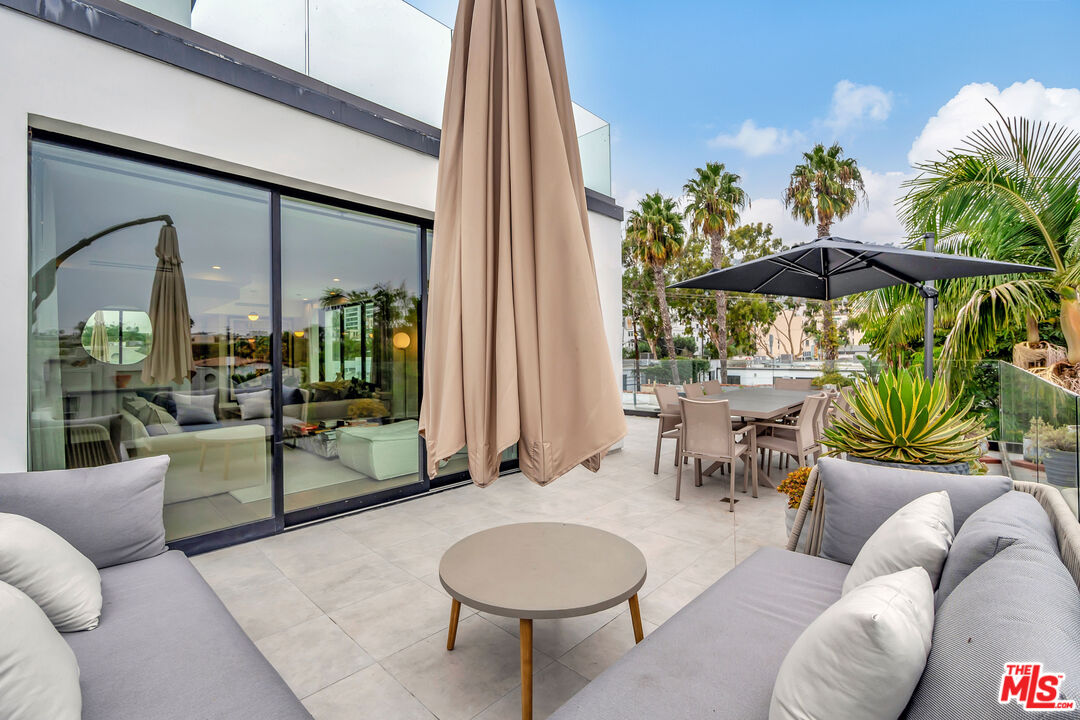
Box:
742 167 912 246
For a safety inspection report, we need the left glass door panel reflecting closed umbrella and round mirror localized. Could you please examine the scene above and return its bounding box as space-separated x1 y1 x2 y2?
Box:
28 140 274 542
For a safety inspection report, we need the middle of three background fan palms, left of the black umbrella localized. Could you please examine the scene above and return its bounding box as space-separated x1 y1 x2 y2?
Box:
683 163 750 382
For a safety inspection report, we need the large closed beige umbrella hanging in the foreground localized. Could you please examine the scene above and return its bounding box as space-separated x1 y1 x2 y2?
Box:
420 0 626 486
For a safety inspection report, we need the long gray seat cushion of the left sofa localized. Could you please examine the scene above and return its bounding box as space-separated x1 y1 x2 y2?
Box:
65 551 311 720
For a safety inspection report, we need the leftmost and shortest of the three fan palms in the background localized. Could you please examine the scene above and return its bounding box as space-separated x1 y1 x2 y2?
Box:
626 192 684 384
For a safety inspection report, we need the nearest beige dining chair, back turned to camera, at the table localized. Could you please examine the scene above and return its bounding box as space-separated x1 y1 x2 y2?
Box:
675 397 757 513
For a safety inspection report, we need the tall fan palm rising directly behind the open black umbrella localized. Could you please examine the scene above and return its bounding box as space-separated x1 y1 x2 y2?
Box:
784 142 866 372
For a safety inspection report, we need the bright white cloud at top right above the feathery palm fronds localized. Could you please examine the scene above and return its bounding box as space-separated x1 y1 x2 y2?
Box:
907 80 1080 164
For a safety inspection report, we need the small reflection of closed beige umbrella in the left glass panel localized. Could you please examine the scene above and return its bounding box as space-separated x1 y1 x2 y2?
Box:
143 223 194 384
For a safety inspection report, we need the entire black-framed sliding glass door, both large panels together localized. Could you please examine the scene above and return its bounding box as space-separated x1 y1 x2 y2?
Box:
27 134 515 548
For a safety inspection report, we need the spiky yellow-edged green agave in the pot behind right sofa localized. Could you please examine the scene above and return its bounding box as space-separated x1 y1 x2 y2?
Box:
824 370 989 465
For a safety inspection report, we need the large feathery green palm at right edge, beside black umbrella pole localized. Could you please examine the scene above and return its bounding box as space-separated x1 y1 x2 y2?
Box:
901 106 1080 386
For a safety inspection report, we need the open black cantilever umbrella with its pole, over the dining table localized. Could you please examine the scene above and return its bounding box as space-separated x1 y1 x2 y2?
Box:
670 234 1054 379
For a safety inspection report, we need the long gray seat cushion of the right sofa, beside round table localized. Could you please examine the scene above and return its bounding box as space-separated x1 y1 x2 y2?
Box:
552 547 848 720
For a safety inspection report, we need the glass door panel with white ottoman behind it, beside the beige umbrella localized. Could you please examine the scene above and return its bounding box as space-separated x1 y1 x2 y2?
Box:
281 198 423 512
